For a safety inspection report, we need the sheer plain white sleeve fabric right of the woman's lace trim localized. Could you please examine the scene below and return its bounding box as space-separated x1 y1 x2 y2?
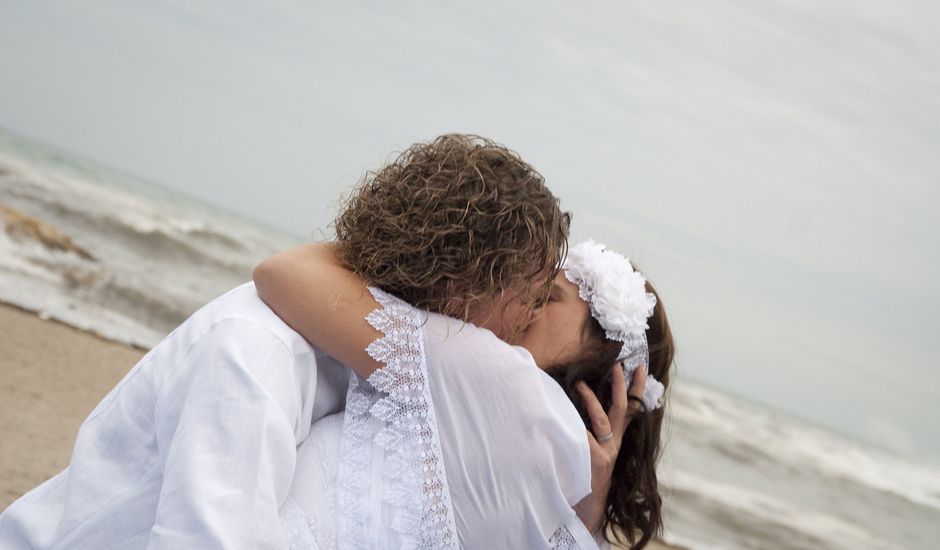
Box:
422 314 591 548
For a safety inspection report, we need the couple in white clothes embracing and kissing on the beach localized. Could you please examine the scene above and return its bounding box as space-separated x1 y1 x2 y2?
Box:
0 135 674 549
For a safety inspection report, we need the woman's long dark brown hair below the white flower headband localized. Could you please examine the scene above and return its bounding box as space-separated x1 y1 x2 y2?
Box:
546 282 675 548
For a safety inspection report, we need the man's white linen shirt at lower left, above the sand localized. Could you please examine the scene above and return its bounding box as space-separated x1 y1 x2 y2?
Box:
0 283 349 550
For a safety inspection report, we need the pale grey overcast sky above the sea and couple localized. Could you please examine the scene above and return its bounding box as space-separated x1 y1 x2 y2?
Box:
0 0 940 464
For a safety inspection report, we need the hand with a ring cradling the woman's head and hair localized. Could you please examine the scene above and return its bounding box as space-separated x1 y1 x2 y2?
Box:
574 361 646 534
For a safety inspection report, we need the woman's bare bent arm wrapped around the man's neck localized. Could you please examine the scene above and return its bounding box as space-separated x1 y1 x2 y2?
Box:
254 243 382 377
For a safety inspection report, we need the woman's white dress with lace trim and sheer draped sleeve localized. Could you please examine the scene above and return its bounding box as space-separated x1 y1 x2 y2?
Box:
281 289 597 550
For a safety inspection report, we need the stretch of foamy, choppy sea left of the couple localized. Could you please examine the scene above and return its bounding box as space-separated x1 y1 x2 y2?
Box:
0 133 298 347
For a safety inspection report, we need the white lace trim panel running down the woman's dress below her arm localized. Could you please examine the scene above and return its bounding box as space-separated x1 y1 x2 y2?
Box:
337 288 458 549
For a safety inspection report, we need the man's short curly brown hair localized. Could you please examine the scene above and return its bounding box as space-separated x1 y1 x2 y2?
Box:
334 134 570 330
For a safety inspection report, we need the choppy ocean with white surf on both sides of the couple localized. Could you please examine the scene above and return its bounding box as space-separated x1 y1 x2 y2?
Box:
0 131 940 549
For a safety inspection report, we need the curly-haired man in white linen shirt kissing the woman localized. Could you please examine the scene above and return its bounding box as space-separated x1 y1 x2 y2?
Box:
0 135 568 548
